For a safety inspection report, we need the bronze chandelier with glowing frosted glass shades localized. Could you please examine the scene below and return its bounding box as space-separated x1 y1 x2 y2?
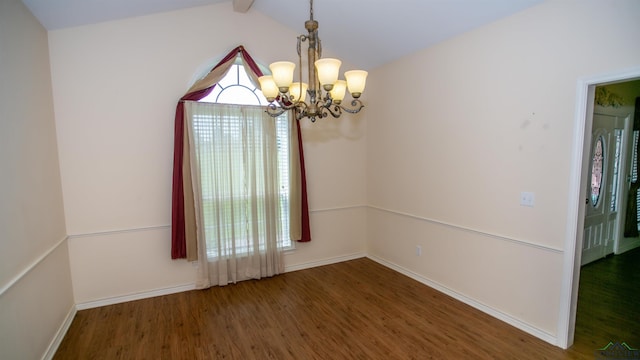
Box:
258 0 367 122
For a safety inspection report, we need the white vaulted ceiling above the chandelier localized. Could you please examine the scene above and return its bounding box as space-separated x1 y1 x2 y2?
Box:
22 0 544 69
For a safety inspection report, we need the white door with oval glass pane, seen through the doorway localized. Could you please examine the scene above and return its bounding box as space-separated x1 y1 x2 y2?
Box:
582 114 624 265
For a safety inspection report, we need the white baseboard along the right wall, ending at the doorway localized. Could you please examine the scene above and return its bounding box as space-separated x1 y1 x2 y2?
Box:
367 255 558 346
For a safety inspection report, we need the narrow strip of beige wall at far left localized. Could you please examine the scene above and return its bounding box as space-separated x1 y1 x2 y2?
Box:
0 0 74 359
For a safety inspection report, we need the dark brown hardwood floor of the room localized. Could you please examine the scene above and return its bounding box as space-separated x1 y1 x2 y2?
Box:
54 253 640 359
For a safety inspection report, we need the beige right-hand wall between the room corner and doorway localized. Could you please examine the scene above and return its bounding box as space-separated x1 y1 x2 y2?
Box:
366 0 640 342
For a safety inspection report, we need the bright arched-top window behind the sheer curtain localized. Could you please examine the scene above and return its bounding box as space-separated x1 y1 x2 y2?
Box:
192 64 292 258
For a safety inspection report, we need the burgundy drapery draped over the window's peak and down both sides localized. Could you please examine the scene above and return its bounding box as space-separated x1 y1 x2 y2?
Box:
171 46 311 259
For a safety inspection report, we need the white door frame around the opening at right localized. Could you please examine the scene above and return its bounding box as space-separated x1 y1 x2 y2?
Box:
557 66 640 349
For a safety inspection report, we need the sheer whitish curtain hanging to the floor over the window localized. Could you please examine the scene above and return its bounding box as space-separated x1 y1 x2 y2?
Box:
185 101 289 288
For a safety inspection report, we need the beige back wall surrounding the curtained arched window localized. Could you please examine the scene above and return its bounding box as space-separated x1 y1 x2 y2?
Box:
49 2 366 306
